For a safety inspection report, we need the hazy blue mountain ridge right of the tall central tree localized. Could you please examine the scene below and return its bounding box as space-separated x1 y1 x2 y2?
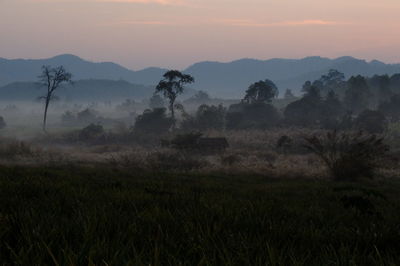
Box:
185 57 400 97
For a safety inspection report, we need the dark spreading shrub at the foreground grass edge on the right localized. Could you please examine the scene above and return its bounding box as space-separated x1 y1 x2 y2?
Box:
305 131 388 180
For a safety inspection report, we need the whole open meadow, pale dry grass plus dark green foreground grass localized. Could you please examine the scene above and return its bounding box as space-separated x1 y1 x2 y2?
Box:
0 121 400 265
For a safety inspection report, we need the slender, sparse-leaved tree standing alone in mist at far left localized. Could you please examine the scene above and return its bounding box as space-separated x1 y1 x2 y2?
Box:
39 66 72 132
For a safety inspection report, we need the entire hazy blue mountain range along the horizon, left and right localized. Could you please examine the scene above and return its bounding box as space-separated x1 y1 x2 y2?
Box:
0 54 400 99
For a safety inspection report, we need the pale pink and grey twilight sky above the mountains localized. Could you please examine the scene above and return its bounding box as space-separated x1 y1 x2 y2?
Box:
0 0 400 70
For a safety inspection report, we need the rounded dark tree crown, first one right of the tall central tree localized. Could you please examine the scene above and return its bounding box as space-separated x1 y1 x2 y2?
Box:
243 79 278 104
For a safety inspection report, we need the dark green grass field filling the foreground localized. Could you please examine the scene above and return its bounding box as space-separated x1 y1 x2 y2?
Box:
0 166 400 265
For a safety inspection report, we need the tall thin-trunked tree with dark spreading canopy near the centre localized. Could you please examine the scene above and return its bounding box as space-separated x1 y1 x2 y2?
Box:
156 70 194 121
